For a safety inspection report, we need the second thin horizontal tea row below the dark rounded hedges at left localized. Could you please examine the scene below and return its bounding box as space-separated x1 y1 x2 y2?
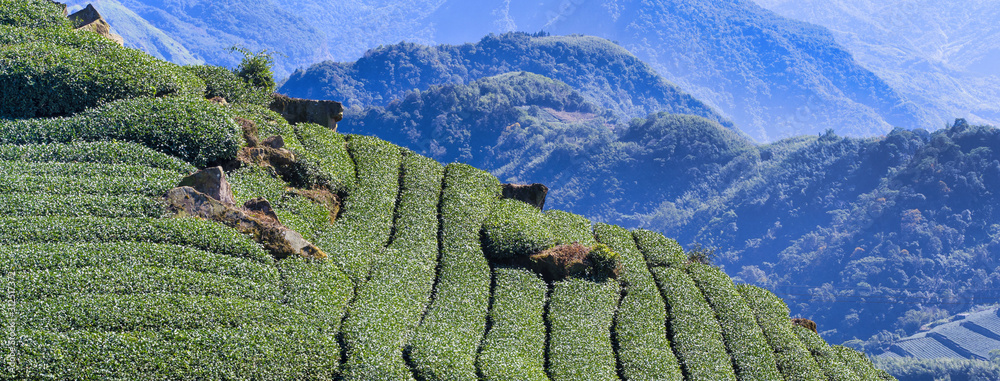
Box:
0 160 179 181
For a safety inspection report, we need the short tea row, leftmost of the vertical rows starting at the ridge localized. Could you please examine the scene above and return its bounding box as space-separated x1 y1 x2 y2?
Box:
316 134 402 286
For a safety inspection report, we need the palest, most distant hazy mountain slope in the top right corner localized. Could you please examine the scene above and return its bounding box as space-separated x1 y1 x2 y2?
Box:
757 0 1000 134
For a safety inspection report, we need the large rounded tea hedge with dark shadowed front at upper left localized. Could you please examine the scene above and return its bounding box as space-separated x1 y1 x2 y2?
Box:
0 36 205 118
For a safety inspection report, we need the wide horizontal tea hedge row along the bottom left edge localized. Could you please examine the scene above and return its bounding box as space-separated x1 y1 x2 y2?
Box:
12 325 338 381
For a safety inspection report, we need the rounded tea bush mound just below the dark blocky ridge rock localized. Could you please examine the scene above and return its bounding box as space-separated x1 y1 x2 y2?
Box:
482 199 556 260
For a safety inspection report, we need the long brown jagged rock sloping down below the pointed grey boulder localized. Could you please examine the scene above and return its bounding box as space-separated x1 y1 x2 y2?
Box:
165 186 327 259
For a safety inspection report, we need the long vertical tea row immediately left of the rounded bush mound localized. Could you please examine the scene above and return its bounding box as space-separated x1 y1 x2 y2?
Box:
410 164 500 381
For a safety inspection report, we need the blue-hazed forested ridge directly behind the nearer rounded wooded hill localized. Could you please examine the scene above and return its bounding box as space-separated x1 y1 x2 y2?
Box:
278 33 733 127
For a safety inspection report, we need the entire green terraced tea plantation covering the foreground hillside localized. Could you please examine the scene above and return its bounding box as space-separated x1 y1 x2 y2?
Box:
0 0 892 381
